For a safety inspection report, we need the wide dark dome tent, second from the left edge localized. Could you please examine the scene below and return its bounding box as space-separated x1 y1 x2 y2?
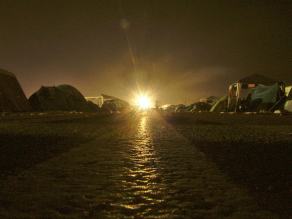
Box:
29 85 99 112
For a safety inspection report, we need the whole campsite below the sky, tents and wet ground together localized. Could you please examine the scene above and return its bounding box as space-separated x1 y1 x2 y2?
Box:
0 70 292 218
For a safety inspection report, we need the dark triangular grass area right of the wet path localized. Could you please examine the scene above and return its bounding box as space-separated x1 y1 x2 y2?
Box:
164 113 292 218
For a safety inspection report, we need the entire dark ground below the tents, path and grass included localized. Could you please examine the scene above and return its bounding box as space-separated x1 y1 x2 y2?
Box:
0 113 292 218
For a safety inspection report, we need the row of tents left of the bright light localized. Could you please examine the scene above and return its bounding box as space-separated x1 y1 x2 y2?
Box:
0 69 129 112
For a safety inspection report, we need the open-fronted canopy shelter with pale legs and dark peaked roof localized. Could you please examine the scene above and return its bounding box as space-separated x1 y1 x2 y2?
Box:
227 74 284 112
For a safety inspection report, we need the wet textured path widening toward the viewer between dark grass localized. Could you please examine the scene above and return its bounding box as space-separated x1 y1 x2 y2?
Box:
0 114 288 218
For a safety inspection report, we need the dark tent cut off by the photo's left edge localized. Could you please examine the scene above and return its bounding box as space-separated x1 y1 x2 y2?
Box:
0 69 30 112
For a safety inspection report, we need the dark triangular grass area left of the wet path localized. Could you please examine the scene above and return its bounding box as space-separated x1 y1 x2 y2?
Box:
0 112 134 178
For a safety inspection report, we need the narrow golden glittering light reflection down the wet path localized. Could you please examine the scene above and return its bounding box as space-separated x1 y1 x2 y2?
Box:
116 115 165 217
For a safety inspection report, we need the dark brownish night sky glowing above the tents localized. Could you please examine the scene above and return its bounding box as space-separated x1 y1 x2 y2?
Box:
0 0 292 103
